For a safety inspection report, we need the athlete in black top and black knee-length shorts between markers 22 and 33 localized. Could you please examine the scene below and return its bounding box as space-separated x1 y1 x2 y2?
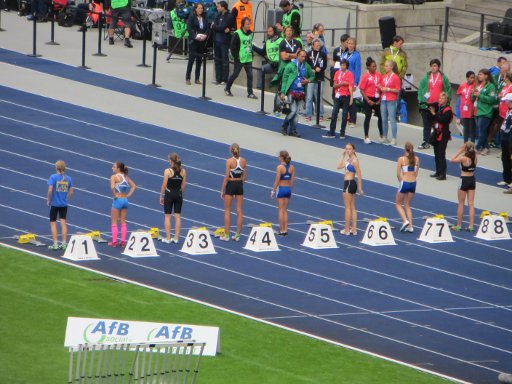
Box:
160 153 187 244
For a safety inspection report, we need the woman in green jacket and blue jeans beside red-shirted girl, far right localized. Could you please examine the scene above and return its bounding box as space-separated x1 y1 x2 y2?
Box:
471 68 498 156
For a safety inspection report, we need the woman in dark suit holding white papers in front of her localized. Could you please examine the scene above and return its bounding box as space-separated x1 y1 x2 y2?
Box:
185 3 210 85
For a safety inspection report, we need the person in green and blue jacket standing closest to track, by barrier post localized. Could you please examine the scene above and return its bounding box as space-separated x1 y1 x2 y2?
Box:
280 50 315 137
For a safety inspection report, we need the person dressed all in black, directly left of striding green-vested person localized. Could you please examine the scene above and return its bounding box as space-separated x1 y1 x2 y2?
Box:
211 1 235 85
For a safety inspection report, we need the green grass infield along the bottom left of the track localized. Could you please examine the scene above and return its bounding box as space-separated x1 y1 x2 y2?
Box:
0 247 447 384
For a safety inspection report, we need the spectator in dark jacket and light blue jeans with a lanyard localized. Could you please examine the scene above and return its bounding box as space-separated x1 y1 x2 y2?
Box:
306 39 327 121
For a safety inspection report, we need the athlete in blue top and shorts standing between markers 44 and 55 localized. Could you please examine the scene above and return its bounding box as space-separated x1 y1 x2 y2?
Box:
270 151 295 236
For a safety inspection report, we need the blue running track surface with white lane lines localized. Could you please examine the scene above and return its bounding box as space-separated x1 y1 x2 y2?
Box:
0 51 512 384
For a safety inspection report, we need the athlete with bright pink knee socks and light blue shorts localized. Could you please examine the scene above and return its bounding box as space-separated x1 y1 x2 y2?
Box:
108 161 136 247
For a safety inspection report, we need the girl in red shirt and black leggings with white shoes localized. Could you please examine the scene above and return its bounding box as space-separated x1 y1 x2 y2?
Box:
359 57 384 144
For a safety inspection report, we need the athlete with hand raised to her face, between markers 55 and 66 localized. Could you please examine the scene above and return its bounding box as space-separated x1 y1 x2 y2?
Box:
337 143 363 235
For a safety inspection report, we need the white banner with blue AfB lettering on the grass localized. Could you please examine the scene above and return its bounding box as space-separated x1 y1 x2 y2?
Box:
64 317 220 356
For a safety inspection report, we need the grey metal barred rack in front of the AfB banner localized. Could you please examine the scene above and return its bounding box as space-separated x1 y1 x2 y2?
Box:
68 342 206 384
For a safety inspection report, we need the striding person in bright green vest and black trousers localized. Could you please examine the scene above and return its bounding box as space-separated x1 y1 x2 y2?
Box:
224 17 257 99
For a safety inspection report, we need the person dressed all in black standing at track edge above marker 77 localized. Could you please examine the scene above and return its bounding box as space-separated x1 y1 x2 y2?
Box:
428 92 453 180
